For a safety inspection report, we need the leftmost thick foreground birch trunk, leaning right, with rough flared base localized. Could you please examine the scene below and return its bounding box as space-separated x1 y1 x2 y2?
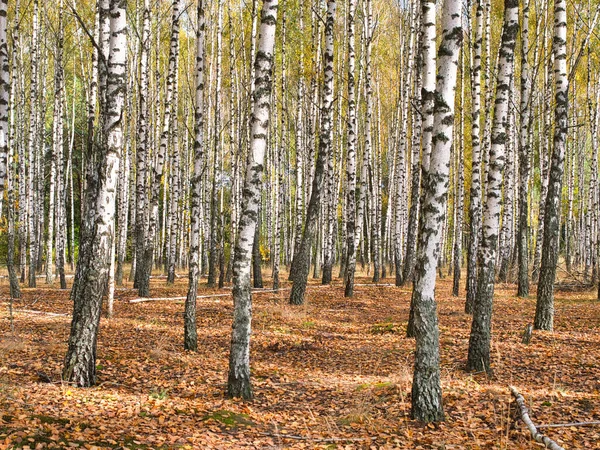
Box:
63 0 127 387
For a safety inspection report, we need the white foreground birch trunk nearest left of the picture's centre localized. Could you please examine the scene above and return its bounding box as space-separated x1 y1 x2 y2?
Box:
227 0 278 399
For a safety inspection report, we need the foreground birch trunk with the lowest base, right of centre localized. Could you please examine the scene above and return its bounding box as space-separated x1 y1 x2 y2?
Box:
411 0 462 422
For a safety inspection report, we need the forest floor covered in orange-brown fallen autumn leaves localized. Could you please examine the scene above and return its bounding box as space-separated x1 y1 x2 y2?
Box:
0 268 600 449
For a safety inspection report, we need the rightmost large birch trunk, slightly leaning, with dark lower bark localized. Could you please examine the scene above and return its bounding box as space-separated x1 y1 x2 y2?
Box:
534 0 569 331
